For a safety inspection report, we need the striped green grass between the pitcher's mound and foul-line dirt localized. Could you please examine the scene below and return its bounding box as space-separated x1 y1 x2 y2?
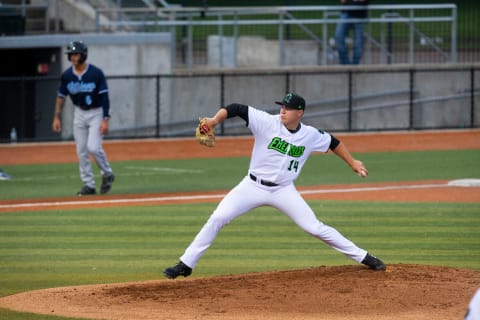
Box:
0 201 480 296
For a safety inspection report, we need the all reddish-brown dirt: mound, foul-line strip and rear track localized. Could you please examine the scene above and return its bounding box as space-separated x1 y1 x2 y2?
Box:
0 130 480 320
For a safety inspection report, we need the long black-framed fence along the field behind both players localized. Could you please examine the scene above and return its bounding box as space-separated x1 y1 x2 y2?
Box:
0 66 480 143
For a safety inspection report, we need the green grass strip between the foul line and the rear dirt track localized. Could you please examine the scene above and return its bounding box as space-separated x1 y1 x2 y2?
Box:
0 150 480 200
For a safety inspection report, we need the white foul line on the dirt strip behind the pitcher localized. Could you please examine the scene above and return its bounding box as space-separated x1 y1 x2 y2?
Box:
0 183 451 209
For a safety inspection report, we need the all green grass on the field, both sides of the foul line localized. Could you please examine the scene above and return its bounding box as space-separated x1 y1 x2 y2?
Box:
0 150 480 320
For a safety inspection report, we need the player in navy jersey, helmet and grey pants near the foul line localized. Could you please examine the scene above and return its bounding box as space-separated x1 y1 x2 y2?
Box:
52 41 115 196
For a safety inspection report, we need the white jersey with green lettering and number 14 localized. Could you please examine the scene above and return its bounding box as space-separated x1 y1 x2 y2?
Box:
248 107 331 185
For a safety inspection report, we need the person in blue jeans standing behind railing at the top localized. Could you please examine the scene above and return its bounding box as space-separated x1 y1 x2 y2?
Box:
335 0 369 64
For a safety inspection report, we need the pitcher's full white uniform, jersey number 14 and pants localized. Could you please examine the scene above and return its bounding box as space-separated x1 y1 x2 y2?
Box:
180 107 367 268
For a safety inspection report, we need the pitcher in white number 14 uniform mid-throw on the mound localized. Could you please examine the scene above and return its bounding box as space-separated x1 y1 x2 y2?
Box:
163 93 386 279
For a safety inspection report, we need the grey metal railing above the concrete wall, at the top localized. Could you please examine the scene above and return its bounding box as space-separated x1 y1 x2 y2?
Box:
96 4 457 68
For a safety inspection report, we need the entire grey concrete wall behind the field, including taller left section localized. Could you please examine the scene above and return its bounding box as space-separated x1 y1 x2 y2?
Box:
0 33 480 139
